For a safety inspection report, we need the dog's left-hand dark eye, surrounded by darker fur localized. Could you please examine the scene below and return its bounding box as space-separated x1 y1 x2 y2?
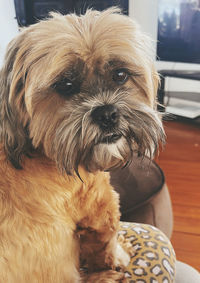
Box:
52 78 80 96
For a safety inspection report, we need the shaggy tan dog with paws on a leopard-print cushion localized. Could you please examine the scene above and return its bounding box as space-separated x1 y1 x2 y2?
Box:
0 8 164 283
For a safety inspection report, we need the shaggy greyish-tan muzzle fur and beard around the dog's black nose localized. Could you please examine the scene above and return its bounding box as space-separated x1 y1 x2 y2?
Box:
39 90 164 174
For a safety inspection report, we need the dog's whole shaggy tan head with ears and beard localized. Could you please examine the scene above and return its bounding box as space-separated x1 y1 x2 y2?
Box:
0 9 164 174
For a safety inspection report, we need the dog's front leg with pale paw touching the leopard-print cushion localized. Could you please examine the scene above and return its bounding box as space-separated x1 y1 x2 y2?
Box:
77 174 130 278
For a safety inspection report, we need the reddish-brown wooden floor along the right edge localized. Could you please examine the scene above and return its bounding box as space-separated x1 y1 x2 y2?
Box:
158 118 200 271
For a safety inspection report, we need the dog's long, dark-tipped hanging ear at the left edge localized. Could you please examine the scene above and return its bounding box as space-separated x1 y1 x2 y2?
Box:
0 35 31 169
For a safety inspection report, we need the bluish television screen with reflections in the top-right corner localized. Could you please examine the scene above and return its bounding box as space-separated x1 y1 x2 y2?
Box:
157 0 200 63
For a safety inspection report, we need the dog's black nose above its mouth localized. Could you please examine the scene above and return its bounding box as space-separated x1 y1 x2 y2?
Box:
91 104 119 129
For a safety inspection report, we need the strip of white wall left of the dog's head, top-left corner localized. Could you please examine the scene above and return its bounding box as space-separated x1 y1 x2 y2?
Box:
0 0 18 66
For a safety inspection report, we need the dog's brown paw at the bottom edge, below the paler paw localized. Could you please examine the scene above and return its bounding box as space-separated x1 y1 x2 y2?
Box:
84 270 128 283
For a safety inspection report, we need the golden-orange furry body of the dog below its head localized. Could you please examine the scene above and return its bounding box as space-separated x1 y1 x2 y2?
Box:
0 149 122 282
